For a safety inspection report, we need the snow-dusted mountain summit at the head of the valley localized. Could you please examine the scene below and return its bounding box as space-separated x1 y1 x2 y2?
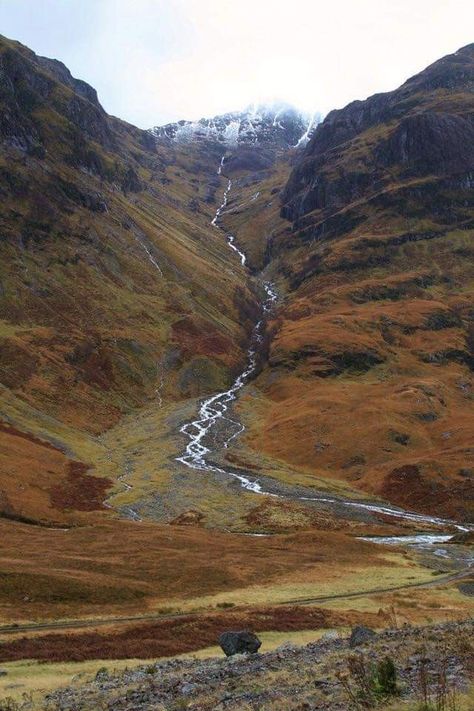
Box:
151 103 321 148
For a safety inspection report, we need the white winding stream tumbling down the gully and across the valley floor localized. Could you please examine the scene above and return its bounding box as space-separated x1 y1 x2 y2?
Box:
176 156 473 565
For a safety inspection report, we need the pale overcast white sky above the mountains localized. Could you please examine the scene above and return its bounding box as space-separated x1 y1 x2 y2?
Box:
0 0 474 128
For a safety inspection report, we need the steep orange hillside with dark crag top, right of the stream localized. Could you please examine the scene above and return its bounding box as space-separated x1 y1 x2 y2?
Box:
242 45 474 519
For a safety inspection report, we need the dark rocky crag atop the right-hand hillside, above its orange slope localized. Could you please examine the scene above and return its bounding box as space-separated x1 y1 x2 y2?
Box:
282 44 474 228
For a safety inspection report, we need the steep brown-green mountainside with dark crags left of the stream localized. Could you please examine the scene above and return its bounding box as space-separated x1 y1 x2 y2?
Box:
0 34 260 440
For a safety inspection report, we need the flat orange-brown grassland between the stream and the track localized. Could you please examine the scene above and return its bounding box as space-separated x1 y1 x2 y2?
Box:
0 521 385 621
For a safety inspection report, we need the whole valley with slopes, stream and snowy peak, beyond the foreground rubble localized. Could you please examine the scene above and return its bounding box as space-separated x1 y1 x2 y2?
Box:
0 32 474 708
